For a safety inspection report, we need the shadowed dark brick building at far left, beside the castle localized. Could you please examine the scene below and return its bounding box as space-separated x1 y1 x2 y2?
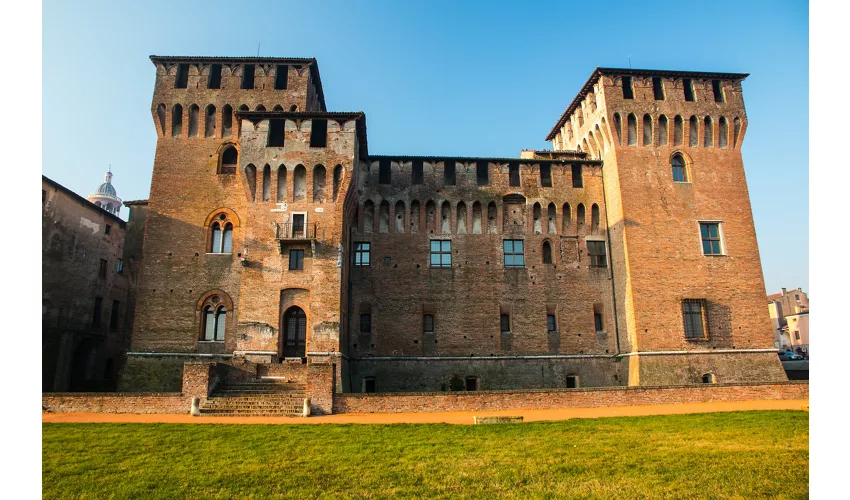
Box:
41 173 130 391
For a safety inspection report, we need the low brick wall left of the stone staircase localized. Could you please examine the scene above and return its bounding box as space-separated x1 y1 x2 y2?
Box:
41 392 192 414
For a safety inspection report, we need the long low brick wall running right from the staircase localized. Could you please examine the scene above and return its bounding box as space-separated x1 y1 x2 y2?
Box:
333 382 809 413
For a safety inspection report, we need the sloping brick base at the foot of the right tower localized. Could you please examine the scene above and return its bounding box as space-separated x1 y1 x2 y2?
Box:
630 352 788 386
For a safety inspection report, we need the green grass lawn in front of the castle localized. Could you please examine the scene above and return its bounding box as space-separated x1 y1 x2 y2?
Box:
42 411 809 499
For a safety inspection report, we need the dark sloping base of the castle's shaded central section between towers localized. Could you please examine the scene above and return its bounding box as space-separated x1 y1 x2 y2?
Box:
343 356 628 393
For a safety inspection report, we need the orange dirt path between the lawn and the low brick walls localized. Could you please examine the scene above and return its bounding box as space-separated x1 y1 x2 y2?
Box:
41 399 809 424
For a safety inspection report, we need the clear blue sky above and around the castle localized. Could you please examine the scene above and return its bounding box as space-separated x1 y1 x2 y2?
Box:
43 0 809 292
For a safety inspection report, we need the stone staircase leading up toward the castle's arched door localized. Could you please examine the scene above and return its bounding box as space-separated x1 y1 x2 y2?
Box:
200 379 306 417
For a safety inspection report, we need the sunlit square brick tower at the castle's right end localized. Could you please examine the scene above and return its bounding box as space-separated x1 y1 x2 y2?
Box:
547 68 786 385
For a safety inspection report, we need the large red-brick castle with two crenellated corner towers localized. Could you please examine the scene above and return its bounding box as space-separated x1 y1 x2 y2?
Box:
117 56 786 392
